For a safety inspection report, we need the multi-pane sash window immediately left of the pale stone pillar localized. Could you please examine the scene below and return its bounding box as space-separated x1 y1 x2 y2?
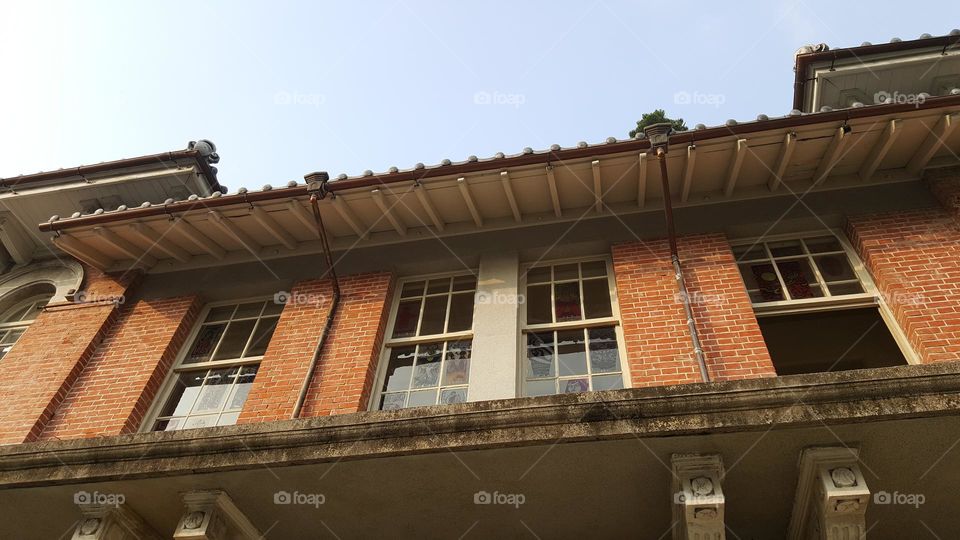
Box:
375 275 477 410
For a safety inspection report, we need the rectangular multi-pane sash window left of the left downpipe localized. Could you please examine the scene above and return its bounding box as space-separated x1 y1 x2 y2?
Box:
152 300 283 431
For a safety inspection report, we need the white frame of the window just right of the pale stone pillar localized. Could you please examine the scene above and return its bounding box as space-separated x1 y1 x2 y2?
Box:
517 255 631 397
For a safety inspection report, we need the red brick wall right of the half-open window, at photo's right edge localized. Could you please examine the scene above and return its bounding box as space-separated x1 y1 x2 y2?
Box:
847 208 960 363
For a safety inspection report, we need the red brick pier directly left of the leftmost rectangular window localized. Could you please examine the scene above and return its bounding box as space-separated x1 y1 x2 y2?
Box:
40 296 201 439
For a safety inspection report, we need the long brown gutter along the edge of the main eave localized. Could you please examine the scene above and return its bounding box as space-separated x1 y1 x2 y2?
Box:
37 95 960 232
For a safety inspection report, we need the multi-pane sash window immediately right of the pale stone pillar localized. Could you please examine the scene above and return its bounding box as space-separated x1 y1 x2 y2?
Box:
522 261 624 396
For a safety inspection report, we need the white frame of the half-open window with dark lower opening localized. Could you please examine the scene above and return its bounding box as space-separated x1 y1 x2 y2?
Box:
730 229 920 364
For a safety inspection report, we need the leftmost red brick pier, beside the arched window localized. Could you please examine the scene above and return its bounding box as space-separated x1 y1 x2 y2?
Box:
0 268 137 443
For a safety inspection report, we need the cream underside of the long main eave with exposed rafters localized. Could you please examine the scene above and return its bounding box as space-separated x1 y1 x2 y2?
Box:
39 96 960 272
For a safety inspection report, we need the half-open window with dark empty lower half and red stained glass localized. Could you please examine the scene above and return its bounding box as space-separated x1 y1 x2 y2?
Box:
733 233 912 375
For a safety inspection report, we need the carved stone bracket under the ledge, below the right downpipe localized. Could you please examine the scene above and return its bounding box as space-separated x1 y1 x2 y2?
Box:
670 454 726 540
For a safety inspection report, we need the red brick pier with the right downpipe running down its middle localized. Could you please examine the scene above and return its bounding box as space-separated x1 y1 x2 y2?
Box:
613 234 776 387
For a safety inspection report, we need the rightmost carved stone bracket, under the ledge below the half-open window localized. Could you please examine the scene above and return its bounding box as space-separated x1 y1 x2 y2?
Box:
787 446 870 540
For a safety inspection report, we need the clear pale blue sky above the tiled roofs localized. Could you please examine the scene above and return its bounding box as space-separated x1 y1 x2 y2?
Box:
0 0 960 191
